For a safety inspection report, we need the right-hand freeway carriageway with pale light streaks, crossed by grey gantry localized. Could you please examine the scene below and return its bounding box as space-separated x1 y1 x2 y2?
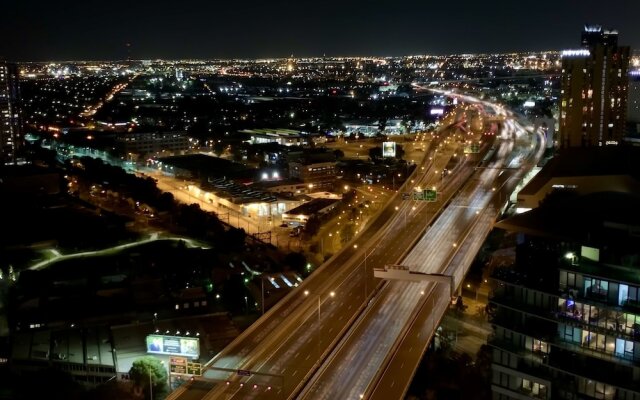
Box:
300 111 544 399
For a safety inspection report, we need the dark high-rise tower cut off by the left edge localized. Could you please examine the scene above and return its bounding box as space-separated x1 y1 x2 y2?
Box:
0 61 23 164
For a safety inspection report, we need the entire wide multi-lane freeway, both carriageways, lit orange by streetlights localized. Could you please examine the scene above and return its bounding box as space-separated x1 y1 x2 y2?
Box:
170 93 544 399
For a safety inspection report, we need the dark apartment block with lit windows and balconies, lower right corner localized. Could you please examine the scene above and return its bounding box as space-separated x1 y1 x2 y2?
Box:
488 195 640 400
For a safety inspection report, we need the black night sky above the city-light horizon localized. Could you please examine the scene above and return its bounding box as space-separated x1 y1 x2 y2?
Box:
0 0 640 61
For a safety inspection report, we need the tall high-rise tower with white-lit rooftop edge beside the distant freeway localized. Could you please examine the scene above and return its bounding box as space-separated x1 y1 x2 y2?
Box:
558 25 629 147
